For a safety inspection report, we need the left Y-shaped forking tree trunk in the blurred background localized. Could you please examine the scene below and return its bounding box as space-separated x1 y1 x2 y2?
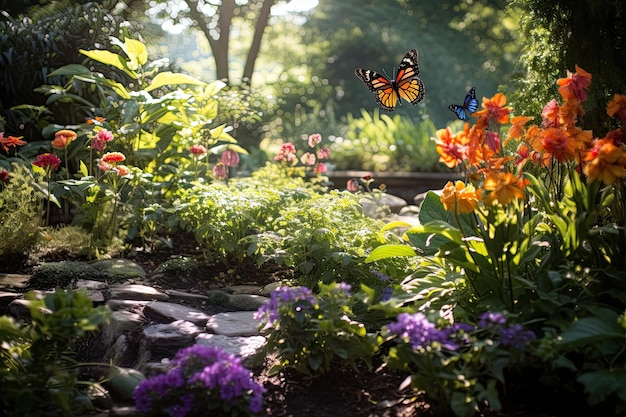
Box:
186 0 235 84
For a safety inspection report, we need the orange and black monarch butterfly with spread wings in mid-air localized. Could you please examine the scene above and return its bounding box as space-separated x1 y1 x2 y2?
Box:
354 49 424 111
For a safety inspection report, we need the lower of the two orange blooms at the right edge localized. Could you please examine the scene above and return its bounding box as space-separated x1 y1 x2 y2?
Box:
583 138 626 185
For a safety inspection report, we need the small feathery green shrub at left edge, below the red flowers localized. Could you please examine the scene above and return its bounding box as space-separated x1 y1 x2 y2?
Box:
0 163 42 260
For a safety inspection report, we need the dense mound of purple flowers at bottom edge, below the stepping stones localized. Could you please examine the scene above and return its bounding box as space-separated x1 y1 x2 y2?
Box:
133 345 265 417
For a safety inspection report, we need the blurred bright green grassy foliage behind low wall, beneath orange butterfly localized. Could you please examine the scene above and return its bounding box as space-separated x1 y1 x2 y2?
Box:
330 110 442 172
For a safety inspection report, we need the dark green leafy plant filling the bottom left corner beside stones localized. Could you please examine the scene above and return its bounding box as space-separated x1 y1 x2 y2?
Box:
0 289 108 417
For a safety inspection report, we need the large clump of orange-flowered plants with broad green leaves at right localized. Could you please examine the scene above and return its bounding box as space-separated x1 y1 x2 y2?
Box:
368 67 626 412
